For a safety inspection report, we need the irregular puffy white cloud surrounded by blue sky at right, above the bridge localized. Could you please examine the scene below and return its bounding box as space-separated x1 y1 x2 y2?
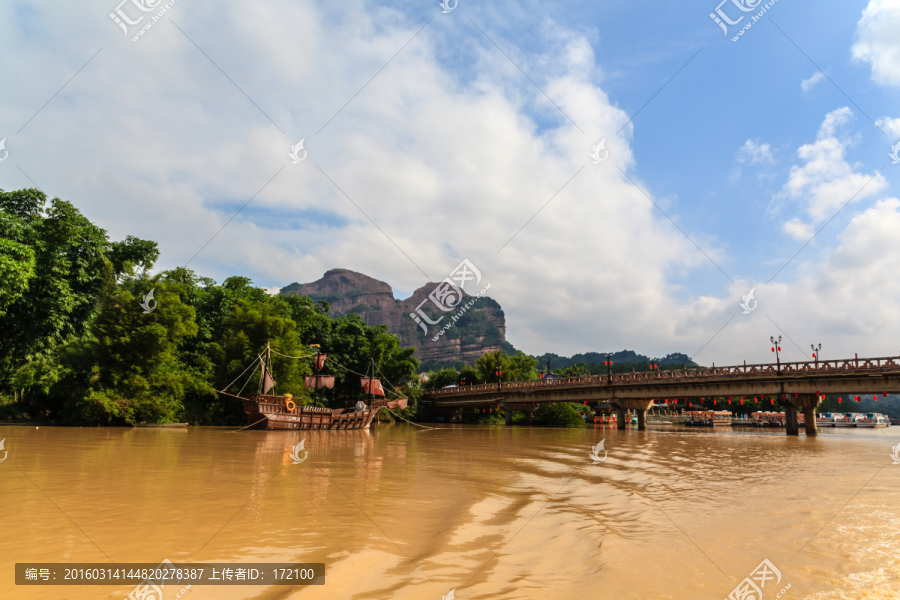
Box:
771 107 887 223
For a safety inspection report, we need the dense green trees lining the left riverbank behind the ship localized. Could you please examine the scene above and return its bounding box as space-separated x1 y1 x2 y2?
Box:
0 190 418 425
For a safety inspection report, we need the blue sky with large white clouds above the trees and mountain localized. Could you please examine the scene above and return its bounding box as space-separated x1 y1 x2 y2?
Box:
0 0 900 364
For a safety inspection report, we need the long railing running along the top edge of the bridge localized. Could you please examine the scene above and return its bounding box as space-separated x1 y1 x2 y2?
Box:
428 356 900 395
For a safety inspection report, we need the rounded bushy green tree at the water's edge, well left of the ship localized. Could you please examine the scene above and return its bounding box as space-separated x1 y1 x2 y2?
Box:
17 276 212 425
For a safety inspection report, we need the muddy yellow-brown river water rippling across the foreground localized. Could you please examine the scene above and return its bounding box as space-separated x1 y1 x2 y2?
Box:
0 424 900 600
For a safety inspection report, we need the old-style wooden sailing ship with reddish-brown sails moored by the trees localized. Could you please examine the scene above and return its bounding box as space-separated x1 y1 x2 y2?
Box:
219 346 407 430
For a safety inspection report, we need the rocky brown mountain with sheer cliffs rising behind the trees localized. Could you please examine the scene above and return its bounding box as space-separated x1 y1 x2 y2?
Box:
281 269 506 364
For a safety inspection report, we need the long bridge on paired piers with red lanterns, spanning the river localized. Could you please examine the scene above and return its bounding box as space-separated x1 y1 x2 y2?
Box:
424 356 900 435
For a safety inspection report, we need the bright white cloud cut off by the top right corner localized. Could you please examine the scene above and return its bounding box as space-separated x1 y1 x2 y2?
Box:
852 0 900 86
